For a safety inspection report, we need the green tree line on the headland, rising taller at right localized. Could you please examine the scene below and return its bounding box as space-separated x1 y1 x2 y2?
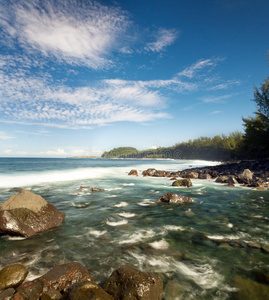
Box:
102 65 269 161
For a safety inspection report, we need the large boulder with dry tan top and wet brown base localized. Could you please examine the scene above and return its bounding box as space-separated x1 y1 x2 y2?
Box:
0 190 65 237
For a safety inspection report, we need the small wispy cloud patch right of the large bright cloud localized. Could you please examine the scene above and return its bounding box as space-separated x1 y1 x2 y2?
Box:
145 28 179 52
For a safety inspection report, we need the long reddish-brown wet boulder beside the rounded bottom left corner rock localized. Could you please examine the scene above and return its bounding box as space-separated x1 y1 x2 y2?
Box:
14 262 92 299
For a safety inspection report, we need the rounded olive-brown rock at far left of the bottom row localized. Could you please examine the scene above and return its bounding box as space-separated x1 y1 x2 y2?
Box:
0 264 29 291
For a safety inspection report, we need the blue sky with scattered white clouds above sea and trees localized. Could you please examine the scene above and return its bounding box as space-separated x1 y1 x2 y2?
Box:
0 0 269 157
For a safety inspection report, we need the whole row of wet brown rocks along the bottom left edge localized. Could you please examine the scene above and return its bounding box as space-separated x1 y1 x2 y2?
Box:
0 262 163 300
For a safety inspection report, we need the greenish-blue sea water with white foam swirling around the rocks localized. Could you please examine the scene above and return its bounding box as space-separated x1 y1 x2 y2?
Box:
0 158 269 300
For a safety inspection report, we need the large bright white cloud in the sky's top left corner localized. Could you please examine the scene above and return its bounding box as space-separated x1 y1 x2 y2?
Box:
0 0 130 69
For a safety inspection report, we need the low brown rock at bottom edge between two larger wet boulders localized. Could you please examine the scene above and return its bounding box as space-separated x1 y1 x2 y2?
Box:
65 281 113 300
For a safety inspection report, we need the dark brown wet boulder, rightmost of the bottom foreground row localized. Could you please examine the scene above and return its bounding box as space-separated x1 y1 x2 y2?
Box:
103 265 163 300
